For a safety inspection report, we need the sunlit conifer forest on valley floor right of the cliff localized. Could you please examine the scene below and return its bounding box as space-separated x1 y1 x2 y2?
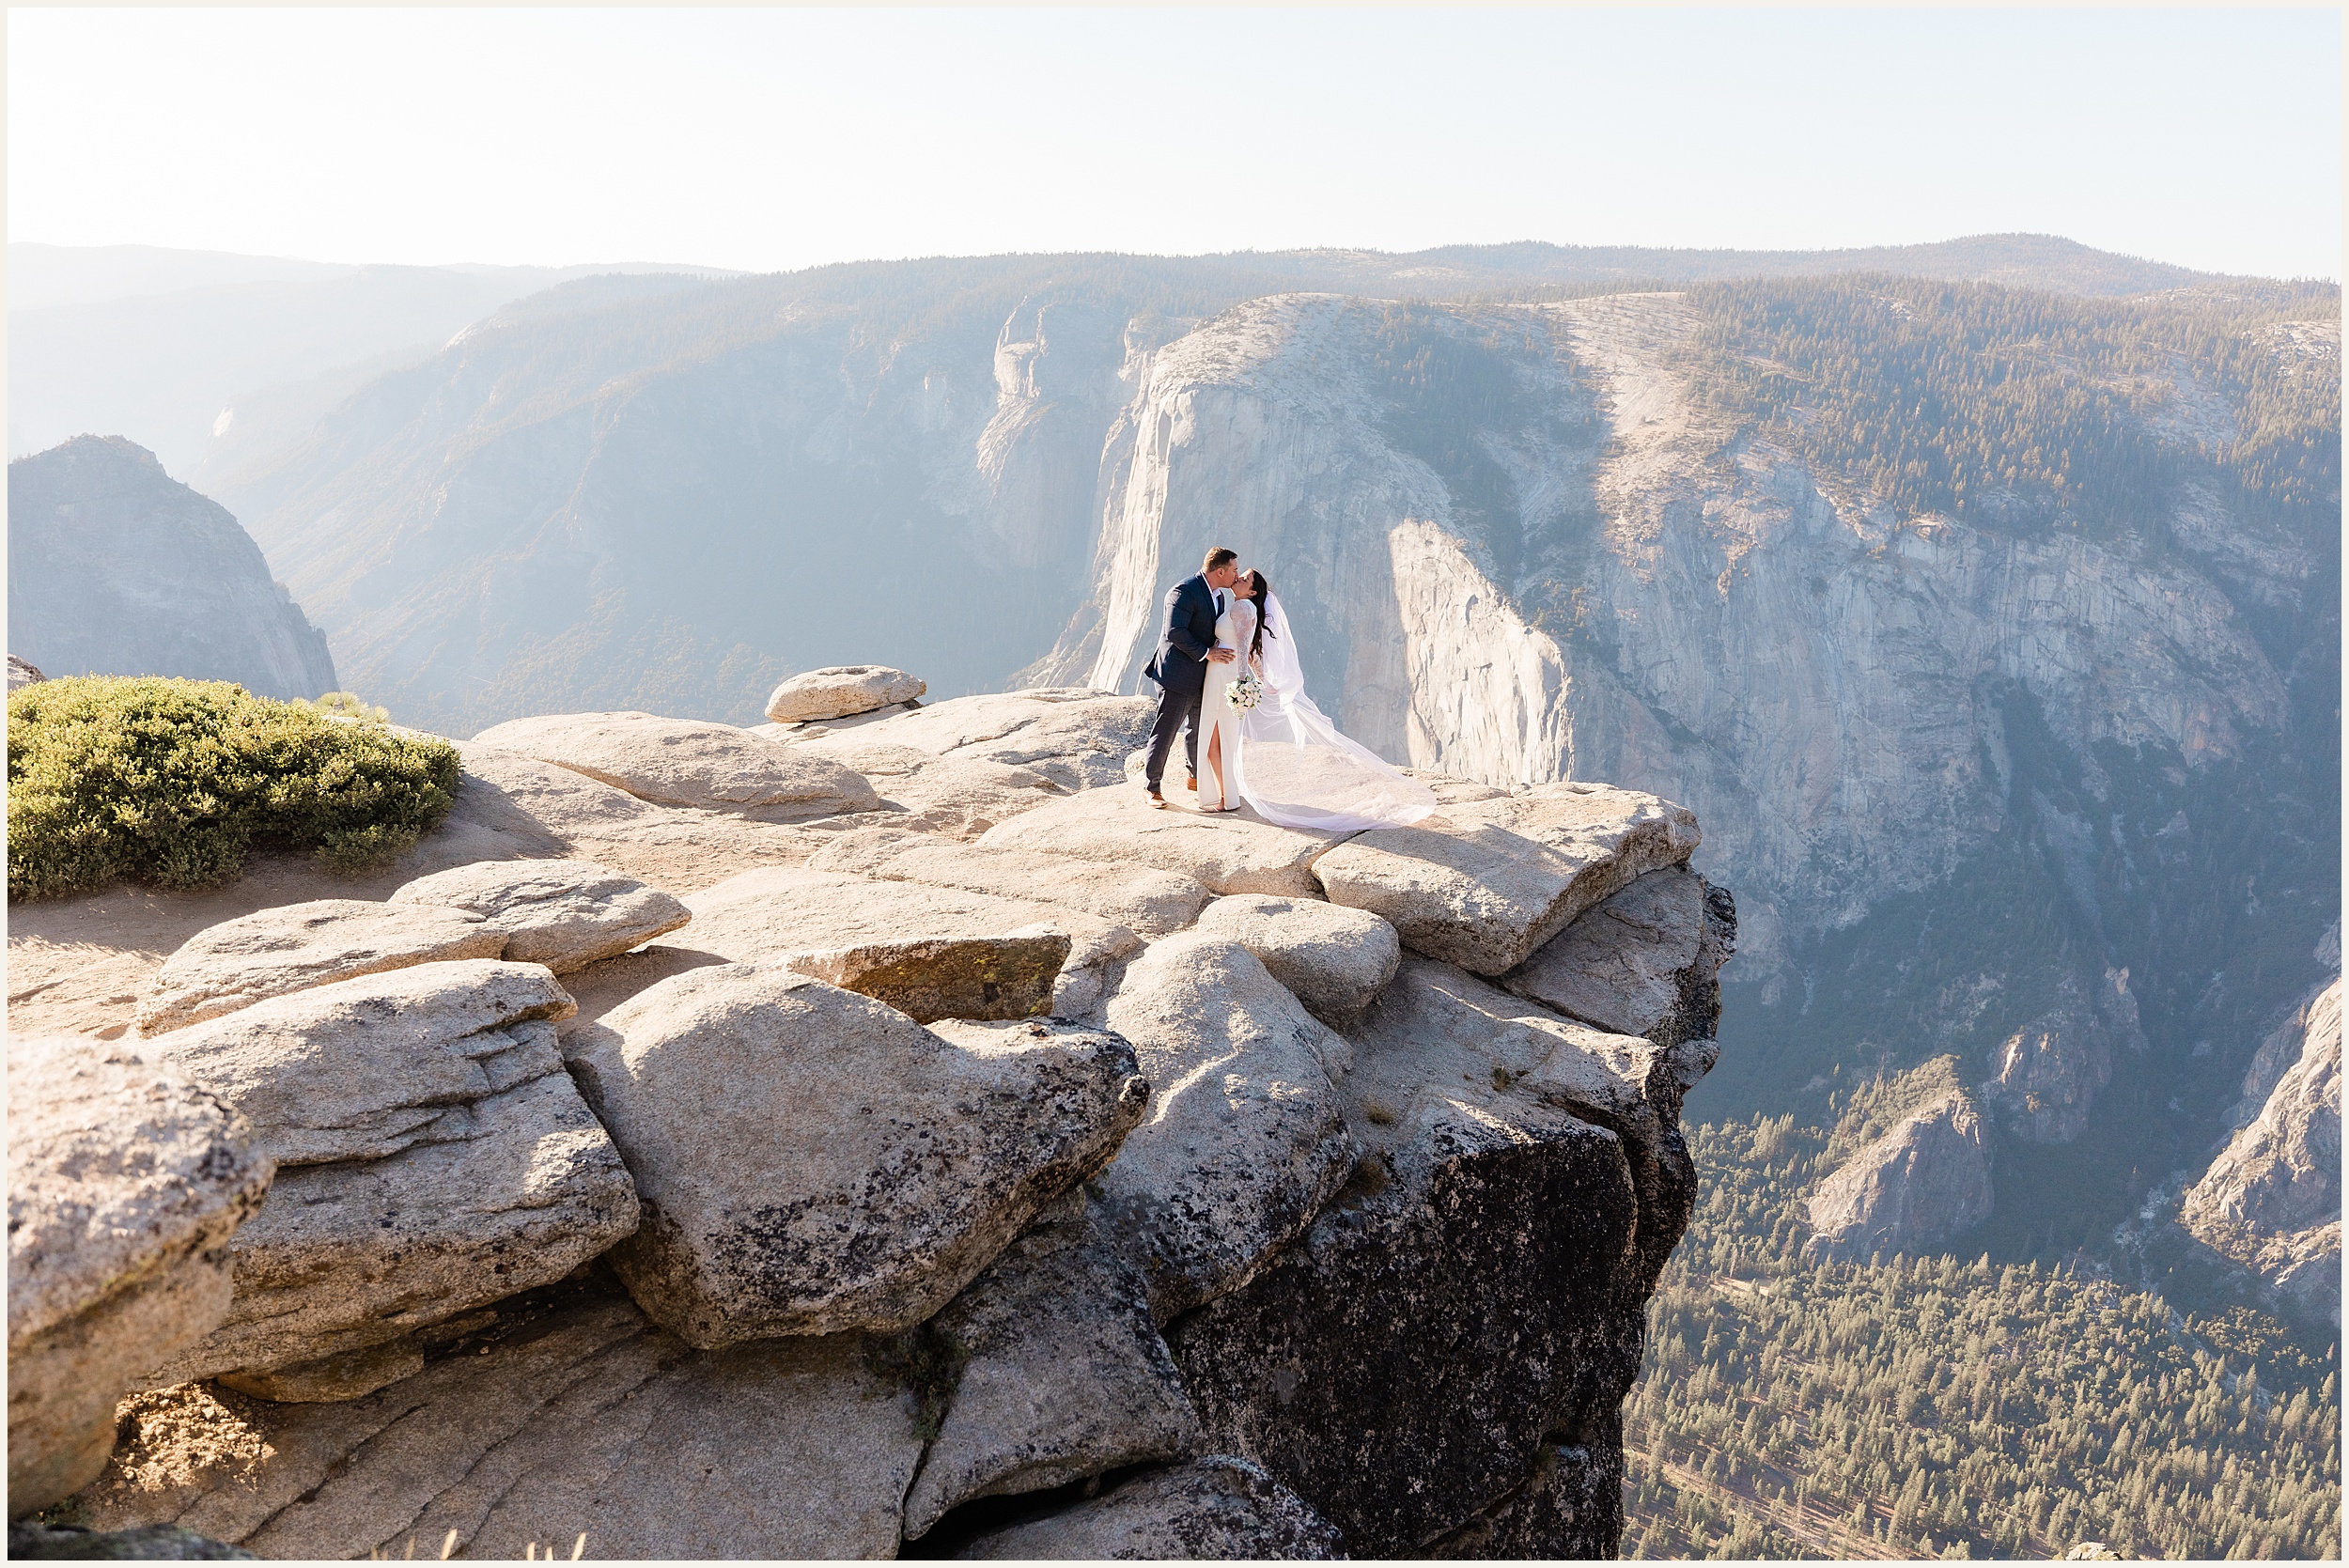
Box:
1624 1110 2342 1559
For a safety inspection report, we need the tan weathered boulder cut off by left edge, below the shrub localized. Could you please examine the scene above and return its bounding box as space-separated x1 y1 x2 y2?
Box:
8 1037 272 1516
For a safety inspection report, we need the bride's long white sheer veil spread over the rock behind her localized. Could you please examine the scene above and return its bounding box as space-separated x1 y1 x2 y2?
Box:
1231 594 1436 833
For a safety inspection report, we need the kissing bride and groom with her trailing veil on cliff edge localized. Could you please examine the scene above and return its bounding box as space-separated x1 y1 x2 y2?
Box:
1142 545 1436 831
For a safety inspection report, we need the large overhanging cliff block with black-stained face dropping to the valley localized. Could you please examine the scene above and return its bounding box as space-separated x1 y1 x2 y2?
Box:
1168 929 1696 1557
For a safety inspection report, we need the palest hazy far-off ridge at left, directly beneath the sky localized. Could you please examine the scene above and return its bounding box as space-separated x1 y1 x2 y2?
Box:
9 244 738 481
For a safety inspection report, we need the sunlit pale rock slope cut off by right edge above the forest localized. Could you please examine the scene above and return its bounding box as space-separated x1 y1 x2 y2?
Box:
2180 979 2342 1327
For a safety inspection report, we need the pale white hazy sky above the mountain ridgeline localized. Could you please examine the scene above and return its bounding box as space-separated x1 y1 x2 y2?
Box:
8 7 2342 277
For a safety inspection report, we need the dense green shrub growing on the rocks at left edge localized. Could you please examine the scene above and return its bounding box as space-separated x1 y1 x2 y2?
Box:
8 676 459 899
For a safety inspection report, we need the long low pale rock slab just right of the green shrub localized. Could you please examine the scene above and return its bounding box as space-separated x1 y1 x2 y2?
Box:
473 714 881 821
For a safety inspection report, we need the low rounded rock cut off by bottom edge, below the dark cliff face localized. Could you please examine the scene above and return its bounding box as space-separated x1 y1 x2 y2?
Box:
957 1455 1346 1561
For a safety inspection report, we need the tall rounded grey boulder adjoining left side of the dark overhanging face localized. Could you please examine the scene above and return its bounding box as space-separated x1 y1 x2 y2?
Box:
1093 937 1353 1322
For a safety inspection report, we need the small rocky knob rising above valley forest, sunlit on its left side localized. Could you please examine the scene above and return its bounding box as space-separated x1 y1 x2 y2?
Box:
1804 1094 1992 1263
